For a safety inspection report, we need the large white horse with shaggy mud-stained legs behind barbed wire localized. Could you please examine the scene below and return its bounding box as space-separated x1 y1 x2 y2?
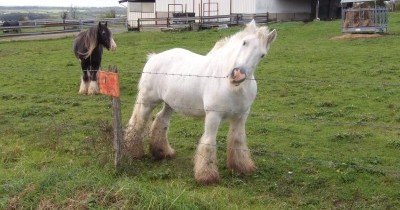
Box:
125 20 277 184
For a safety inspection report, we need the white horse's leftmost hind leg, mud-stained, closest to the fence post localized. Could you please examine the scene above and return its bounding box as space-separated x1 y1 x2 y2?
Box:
124 97 156 158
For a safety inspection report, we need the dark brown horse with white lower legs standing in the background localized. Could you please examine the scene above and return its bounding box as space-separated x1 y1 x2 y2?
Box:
73 22 117 95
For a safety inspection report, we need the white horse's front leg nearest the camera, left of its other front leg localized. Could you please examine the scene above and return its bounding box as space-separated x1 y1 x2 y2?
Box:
194 112 221 184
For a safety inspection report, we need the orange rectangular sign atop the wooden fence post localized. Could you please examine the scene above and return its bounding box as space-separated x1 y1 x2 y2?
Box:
97 71 119 97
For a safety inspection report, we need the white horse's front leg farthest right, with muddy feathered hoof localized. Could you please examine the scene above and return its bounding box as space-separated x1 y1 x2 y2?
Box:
227 115 256 174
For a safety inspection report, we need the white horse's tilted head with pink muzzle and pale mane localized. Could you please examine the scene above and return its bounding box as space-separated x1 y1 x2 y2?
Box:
209 20 277 85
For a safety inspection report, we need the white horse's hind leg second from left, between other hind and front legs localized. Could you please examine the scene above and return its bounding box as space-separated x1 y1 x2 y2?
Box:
150 104 175 159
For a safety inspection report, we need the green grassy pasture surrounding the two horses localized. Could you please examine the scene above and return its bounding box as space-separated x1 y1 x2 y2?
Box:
0 13 400 209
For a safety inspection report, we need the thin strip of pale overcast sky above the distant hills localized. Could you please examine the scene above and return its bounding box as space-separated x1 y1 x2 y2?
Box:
0 0 121 7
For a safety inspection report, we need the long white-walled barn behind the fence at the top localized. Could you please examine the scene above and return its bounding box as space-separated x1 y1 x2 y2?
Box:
119 0 340 27
